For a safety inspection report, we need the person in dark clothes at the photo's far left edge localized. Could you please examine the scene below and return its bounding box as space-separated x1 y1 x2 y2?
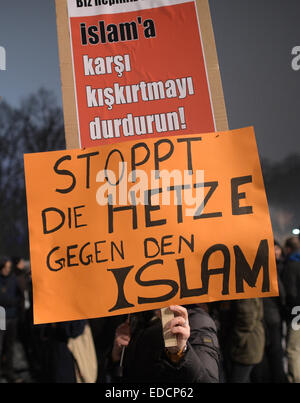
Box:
0 257 22 382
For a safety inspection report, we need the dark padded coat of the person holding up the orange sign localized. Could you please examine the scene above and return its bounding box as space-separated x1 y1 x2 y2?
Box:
119 305 219 383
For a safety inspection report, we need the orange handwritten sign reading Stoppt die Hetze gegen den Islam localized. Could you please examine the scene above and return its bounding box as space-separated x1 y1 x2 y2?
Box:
25 128 277 323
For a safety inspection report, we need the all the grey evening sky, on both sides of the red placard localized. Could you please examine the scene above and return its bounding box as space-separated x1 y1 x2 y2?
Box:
0 0 300 160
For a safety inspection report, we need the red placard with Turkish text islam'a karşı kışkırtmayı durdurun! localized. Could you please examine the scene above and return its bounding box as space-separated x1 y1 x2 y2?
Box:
56 0 227 148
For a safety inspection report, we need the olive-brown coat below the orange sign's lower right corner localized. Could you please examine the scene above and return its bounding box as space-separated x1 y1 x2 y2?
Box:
230 298 265 365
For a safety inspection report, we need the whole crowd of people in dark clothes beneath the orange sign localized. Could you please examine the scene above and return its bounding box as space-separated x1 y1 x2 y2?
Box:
0 237 300 383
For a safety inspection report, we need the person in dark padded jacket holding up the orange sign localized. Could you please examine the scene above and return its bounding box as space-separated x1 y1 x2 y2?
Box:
112 305 219 383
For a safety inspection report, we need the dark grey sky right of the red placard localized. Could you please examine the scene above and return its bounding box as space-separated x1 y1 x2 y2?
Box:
210 0 300 160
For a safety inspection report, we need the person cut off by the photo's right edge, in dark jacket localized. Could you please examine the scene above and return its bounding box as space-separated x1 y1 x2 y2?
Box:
283 237 300 383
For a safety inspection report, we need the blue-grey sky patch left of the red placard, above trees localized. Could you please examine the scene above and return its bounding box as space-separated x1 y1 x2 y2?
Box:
0 0 62 105
